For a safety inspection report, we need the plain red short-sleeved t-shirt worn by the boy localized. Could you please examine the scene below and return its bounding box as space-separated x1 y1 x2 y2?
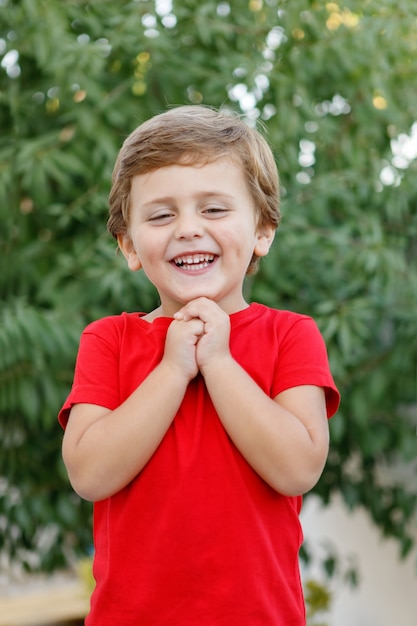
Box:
59 303 339 626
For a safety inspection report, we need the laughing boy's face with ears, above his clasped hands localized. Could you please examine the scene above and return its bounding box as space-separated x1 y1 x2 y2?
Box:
119 158 274 316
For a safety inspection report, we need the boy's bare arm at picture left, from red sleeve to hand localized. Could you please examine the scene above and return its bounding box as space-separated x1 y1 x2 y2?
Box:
62 319 203 501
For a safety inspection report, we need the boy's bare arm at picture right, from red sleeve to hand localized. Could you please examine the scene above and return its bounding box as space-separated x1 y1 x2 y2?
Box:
177 298 329 495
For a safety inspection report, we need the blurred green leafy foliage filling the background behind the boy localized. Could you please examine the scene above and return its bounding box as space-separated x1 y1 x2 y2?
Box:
0 0 417 569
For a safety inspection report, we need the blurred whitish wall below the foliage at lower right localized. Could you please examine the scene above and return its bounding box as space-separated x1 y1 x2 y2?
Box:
301 497 417 626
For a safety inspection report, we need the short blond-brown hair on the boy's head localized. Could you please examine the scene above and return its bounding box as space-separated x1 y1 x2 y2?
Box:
107 105 280 273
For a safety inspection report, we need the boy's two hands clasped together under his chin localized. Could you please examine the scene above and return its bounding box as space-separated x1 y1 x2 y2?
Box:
163 298 230 380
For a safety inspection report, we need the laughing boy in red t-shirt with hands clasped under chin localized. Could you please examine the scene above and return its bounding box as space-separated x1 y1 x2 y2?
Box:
60 106 339 626
